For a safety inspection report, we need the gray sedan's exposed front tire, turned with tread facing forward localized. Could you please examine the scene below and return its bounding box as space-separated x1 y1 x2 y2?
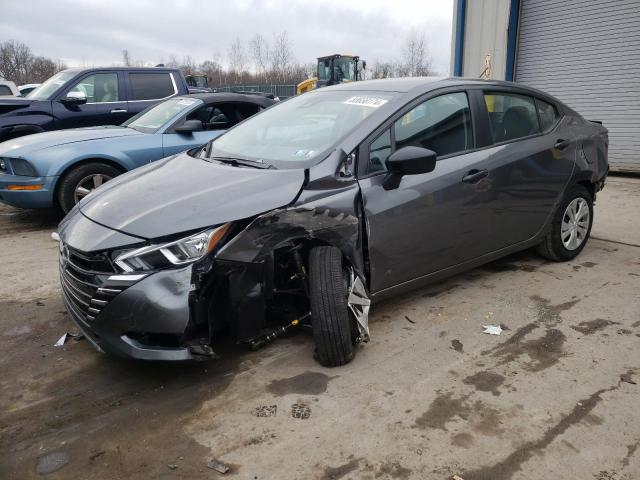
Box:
309 247 353 367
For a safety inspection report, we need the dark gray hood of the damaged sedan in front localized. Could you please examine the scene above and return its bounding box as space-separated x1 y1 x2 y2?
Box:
79 153 305 239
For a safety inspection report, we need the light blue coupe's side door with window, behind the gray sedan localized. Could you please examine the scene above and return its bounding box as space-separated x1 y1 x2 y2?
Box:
162 102 260 156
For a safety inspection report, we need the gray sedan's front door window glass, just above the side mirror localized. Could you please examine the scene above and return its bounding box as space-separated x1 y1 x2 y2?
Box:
394 93 473 156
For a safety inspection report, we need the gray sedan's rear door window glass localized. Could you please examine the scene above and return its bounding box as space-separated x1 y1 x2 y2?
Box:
484 92 540 143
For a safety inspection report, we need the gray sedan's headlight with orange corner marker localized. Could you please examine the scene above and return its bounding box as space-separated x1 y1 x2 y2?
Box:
115 223 231 272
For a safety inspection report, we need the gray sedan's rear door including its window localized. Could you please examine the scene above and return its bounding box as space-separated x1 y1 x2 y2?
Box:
476 89 576 249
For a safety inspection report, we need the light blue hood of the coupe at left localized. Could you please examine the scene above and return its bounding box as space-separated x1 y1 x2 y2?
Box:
0 126 145 157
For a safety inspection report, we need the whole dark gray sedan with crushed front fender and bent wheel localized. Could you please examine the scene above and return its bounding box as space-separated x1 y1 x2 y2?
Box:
59 78 608 366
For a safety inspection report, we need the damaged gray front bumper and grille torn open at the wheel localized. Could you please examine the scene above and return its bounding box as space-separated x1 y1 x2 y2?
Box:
60 246 194 361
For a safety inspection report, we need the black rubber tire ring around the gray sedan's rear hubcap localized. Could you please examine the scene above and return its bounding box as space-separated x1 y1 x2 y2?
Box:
537 185 593 262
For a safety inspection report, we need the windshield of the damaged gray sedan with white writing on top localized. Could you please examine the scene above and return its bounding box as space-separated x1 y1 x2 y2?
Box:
210 90 396 168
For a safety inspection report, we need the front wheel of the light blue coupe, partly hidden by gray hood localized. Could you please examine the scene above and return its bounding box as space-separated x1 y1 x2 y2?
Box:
58 162 120 213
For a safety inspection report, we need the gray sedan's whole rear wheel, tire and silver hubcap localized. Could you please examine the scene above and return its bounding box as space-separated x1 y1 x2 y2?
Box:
537 185 593 262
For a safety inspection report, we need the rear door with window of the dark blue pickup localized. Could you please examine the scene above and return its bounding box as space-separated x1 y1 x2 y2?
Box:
125 71 178 116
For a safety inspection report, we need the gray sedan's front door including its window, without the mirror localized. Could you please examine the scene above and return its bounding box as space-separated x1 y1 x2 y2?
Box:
359 92 492 293
